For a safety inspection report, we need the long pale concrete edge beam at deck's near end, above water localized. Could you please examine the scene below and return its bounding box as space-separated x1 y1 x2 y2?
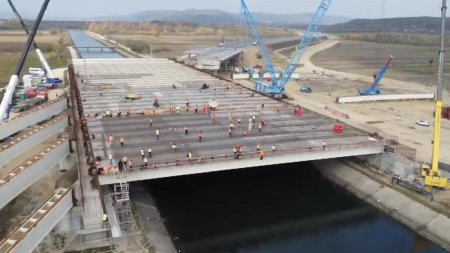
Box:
99 145 383 185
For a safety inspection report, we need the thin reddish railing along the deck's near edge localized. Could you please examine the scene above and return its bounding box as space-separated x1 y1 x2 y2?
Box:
98 140 383 176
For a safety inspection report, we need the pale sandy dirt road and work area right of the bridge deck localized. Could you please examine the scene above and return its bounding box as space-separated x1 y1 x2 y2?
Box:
286 39 450 163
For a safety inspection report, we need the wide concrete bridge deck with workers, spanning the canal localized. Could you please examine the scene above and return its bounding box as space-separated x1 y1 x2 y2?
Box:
74 59 382 184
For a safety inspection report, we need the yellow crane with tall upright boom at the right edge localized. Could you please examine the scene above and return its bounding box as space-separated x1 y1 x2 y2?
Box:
421 0 450 194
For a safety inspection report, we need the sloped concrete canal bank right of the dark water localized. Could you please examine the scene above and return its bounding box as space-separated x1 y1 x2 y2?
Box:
313 159 450 251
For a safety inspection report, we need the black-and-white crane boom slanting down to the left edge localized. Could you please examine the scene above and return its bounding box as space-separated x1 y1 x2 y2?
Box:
0 0 50 121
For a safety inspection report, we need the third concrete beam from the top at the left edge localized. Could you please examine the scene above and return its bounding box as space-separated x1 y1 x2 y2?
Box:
0 138 70 209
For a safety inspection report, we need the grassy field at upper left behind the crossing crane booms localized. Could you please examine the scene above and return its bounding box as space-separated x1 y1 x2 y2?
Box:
0 31 69 87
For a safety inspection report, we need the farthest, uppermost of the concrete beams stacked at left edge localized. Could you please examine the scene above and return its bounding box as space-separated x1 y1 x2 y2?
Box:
0 97 67 139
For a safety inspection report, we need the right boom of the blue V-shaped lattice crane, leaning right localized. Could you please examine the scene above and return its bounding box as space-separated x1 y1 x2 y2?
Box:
278 0 332 93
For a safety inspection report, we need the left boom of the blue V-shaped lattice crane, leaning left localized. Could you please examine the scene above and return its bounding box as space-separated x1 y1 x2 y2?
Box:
241 0 278 86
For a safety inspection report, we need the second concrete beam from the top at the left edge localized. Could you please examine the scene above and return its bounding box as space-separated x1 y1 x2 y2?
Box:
0 115 69 167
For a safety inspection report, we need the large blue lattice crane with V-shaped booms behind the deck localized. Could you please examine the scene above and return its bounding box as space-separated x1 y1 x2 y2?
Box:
241 0 332 97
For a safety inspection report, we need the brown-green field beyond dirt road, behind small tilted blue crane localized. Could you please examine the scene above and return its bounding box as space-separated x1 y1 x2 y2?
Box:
312 41 450 88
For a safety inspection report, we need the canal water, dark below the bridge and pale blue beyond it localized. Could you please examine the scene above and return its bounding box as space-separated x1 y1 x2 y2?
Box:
70 31 446 253
